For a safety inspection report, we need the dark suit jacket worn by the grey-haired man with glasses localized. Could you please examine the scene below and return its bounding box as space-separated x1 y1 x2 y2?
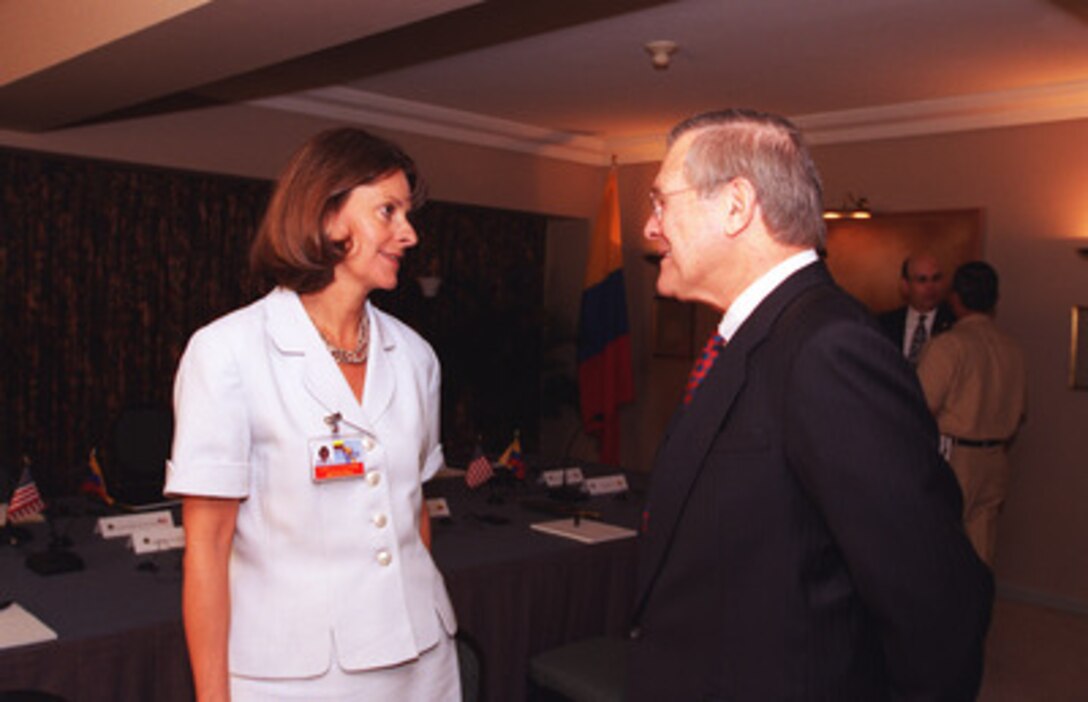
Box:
628 262 993 702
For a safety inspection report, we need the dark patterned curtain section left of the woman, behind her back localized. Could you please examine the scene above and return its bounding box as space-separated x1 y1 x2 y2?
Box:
0 150 270 494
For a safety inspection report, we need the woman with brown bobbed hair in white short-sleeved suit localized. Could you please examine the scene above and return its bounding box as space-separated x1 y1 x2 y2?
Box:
165 128 460 702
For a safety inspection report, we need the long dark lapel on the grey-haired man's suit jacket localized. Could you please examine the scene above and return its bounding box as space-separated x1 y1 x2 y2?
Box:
636 262 830 608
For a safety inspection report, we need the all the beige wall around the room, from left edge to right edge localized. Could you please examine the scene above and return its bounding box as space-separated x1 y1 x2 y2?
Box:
0 103 1088 611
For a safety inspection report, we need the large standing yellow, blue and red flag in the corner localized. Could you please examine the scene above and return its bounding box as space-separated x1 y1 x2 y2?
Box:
578 162 634 466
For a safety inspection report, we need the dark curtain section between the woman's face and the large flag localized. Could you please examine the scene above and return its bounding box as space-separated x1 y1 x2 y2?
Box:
374 202 547 465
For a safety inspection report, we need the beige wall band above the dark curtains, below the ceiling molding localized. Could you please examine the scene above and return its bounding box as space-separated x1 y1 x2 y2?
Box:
0 106 604 218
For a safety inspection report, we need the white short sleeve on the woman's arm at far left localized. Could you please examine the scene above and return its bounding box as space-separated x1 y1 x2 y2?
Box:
163 328 250 498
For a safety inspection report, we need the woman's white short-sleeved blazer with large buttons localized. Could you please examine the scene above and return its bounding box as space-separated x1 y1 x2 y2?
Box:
164 288 456 678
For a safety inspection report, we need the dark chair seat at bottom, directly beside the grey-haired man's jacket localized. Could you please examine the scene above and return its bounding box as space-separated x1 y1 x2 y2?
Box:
529 637 627 702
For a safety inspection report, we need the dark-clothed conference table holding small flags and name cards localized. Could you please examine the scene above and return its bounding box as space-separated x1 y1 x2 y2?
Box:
0 465 642 702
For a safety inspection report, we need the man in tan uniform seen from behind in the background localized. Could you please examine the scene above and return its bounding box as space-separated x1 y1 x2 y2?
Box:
918 261 1027 567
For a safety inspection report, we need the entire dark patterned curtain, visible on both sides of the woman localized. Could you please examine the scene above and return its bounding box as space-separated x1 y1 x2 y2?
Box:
0 149 545 495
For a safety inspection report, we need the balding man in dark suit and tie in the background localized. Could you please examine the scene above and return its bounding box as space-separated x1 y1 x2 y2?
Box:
879 254 955 366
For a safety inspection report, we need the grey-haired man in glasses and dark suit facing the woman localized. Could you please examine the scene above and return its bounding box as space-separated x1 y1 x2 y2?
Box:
627 110 993 702
